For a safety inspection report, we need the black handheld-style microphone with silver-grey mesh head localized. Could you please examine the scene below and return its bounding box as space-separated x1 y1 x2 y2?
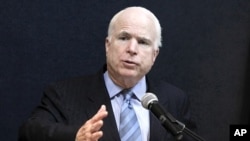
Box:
141 93 185 140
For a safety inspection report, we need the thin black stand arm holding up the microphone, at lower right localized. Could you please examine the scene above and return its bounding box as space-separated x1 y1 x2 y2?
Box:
174 120 205 141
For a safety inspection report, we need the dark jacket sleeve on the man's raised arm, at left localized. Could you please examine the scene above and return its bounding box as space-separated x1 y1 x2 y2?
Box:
18 86 79 141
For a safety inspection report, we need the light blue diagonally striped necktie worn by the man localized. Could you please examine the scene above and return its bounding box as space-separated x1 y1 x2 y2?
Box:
119 90 142 141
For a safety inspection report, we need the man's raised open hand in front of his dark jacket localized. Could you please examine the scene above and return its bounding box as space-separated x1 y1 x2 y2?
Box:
76 105 108 141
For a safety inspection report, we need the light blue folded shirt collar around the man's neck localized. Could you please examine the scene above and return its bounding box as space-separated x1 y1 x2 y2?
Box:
103 71 147 101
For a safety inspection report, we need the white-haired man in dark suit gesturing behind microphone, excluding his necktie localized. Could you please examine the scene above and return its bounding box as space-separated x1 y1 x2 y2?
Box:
19 7 195 141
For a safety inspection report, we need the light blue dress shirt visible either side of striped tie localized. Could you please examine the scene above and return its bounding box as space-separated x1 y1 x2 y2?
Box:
104 71 150 141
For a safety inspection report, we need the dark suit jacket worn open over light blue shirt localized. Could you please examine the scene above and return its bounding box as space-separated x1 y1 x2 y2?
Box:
19 69 195 141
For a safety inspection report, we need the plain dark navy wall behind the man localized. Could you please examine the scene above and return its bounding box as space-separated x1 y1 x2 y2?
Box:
0 0 250 141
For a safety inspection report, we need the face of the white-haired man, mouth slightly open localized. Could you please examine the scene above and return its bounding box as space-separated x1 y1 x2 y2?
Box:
106 9 158 85
